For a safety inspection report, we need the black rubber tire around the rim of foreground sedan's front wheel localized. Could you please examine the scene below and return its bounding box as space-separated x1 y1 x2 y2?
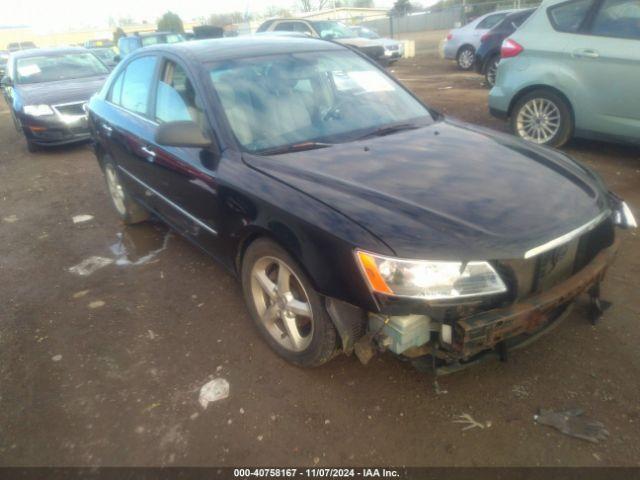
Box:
241 238 336 367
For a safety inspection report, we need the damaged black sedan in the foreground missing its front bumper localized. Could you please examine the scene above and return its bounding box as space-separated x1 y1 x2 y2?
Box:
89 36 635 368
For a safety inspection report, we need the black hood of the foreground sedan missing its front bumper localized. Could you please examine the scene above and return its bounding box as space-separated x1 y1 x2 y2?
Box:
244 121 610 260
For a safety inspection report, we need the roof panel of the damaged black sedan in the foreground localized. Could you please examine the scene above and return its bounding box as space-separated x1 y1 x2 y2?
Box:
140 35 346 63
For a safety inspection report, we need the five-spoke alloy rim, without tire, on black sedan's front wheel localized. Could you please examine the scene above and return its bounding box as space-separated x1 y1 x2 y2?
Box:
251 257 314 352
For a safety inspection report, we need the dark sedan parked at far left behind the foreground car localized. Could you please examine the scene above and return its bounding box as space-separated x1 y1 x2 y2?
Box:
2 48 109 151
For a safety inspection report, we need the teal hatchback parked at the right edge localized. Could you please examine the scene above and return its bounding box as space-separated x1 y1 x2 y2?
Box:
489 0 640 147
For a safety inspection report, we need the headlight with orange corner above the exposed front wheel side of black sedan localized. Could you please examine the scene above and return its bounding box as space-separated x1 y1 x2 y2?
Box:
356 250 507 300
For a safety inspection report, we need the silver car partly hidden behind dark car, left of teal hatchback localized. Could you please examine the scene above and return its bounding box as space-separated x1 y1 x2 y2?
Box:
440 9 518 70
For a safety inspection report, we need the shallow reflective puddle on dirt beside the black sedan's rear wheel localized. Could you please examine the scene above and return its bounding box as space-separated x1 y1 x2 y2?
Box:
109 228 171 267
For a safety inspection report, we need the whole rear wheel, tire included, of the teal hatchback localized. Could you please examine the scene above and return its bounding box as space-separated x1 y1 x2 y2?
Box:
511 89 573 148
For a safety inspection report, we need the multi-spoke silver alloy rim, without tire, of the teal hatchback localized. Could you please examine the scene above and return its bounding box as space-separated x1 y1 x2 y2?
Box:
516 98 562 144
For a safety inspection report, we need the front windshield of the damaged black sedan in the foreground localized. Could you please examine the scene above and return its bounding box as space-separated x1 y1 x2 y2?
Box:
210 51 433 153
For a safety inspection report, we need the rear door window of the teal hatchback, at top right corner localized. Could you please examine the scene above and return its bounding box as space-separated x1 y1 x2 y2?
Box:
591 0 640 40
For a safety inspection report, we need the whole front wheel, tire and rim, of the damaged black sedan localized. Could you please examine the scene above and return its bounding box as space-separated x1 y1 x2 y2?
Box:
241 238 337 367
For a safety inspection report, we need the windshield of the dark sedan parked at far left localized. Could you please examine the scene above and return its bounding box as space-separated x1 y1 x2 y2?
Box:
16 52 109 84
